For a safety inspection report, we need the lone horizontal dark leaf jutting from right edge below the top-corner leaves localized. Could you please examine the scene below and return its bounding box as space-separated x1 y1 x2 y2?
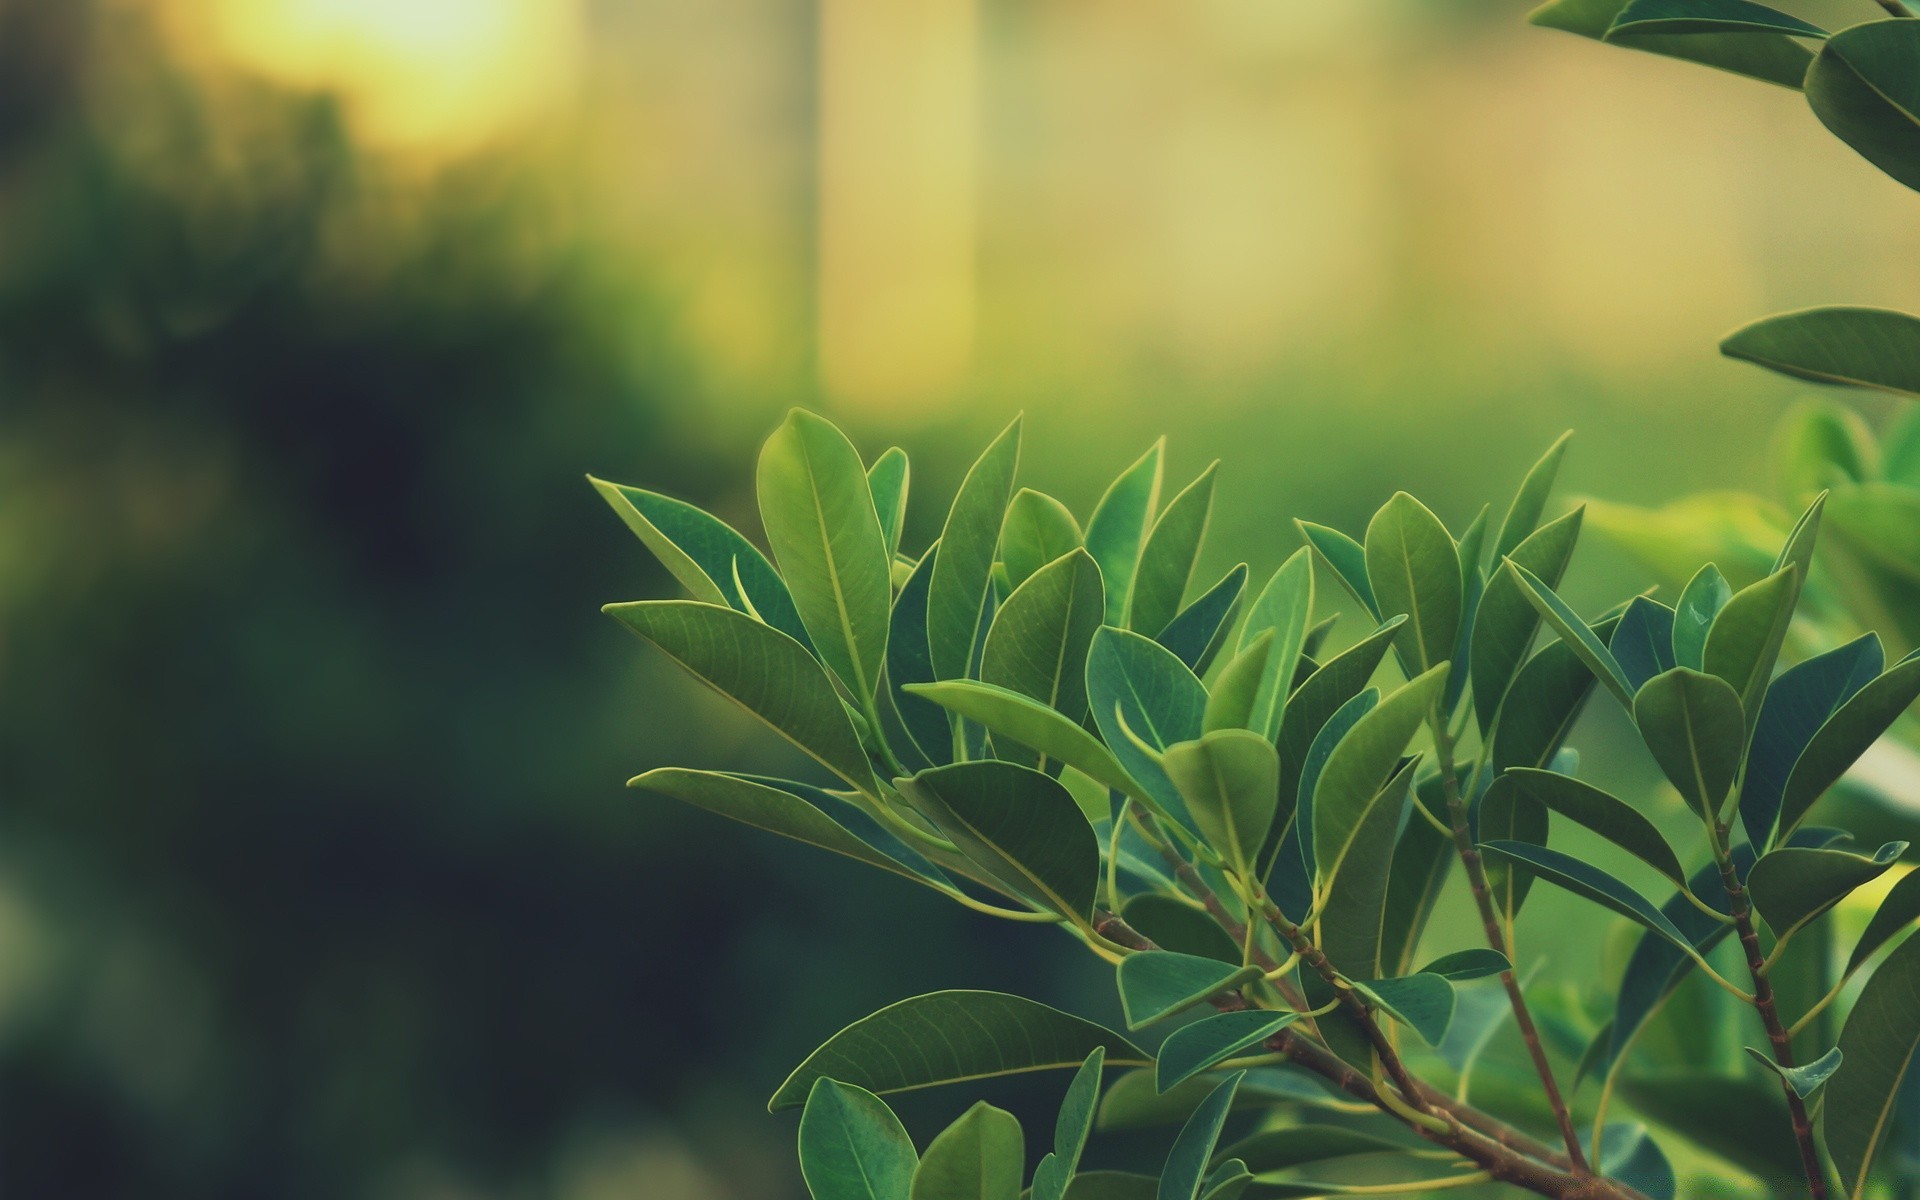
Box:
1720 307 1920 396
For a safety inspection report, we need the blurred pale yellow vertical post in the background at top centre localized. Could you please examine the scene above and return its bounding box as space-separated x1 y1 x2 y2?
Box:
818 0 979 409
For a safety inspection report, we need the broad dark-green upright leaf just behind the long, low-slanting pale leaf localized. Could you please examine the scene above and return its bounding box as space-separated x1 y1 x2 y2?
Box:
979 549 1104 722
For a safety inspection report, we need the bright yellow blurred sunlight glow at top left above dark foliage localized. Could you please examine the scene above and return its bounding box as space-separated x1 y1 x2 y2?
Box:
207 0 578 154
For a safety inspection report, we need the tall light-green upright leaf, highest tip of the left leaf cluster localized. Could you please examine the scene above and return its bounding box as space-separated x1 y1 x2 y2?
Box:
758 409 893 708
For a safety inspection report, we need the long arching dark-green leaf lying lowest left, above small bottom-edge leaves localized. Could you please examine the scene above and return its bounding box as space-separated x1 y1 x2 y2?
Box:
768 991 1152 1112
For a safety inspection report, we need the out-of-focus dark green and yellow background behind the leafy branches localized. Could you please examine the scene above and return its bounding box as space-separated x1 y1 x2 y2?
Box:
0 0 1920 1200
